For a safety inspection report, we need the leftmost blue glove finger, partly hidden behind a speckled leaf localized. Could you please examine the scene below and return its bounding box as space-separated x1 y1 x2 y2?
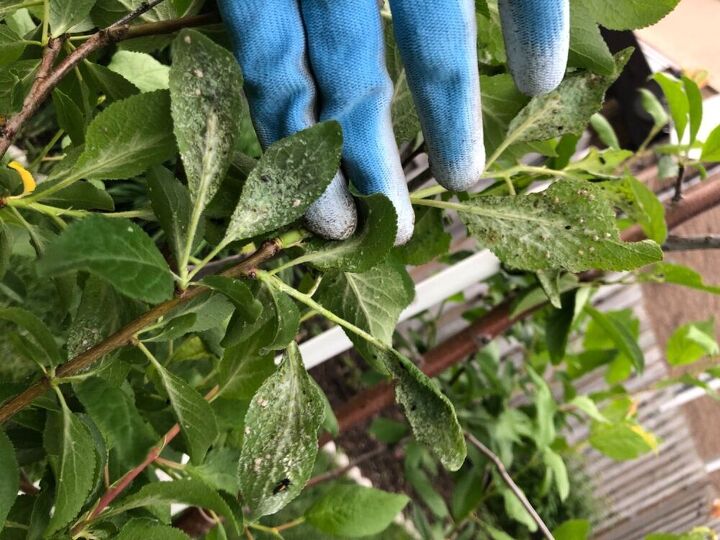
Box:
218 0 357 240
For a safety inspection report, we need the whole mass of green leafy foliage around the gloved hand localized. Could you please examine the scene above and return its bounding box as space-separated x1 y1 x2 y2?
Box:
0 0 720 539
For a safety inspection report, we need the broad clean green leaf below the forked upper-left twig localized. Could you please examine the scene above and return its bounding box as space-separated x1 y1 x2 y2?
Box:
71 91 175 180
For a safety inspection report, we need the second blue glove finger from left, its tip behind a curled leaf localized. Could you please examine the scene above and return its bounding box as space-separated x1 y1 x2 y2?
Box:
301 0 415 244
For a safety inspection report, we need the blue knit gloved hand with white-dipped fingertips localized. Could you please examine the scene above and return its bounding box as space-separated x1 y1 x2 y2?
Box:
219 0 569 244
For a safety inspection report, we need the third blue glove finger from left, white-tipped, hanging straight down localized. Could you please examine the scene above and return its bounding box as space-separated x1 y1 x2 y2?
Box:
390 0 485 191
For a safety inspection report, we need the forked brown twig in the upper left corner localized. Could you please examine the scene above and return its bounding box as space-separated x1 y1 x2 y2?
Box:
0 7 219 158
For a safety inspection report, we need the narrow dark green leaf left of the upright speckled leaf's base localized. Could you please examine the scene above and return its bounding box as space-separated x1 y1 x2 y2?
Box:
146 167 197 261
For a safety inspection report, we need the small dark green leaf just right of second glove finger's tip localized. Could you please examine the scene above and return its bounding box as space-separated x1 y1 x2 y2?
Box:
390 207 452 266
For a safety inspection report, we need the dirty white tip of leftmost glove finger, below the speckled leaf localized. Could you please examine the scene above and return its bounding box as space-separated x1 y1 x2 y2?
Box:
305 172 357 240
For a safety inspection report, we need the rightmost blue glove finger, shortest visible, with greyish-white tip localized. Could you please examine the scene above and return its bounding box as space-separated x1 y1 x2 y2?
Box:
499 0 570 96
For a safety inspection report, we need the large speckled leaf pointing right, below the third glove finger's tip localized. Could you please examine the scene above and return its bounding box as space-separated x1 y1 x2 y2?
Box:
458 180 662 272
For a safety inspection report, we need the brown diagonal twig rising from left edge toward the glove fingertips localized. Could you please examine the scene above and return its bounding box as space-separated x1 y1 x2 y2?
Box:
0 240 282 424
